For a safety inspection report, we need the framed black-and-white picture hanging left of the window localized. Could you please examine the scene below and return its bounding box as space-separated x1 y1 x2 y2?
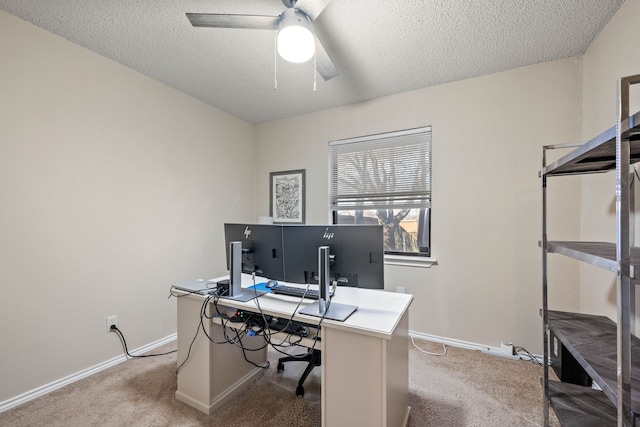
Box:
269 169 305 224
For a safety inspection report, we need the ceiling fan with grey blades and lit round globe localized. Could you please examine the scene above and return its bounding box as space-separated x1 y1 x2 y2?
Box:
187 0 338 80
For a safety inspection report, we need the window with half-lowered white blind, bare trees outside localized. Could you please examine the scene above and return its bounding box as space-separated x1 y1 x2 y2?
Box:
329 126 431 257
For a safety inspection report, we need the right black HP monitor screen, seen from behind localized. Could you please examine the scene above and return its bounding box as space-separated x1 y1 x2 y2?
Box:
282 225 384 289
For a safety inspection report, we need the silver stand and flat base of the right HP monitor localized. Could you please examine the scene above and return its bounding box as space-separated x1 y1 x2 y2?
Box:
298 246 358 322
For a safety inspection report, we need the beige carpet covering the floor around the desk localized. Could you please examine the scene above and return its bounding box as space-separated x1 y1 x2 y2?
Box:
0 340 555 427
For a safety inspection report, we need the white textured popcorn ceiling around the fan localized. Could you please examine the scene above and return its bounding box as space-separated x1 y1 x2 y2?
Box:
0 0 623 123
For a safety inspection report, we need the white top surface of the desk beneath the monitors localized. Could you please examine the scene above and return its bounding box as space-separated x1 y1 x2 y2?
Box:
176 274 413 339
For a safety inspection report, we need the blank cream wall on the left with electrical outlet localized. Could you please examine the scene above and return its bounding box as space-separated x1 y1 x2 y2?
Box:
0 11 256 402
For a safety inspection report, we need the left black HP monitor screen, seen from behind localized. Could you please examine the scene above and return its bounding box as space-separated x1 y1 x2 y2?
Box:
224 224 285 280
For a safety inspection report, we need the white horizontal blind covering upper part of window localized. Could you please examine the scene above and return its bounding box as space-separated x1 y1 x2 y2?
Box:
329 126 431 210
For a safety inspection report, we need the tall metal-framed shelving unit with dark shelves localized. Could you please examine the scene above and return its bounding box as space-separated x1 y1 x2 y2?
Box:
539 75 640 427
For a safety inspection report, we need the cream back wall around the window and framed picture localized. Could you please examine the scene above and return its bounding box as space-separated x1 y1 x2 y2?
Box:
256 58 582 354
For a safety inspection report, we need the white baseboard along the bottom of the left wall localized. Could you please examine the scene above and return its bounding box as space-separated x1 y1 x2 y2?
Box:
0 334 178 412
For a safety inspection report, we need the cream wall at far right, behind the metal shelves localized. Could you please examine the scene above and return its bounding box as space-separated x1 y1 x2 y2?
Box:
580 0 640 319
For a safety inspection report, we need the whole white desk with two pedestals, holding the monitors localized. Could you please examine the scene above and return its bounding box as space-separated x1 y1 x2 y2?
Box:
174 274 413 427
